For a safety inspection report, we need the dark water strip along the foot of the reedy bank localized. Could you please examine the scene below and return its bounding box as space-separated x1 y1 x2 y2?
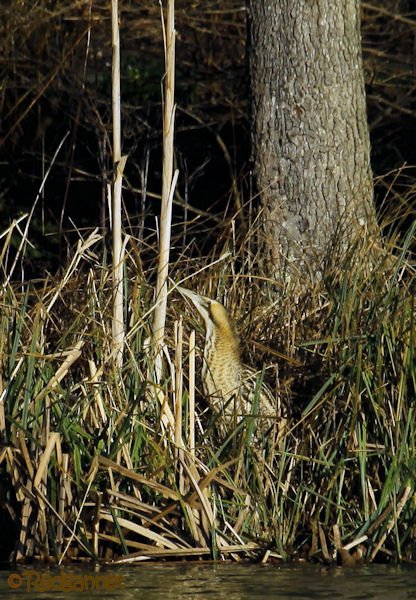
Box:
0 563 416 600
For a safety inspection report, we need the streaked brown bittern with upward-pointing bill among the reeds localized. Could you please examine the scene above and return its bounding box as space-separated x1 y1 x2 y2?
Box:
178 286 285 438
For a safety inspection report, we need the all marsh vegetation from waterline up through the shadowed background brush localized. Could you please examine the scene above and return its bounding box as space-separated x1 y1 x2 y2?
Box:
0 0 416 564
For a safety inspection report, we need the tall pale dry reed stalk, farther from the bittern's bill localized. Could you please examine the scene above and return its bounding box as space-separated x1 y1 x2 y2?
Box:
111 0 127 369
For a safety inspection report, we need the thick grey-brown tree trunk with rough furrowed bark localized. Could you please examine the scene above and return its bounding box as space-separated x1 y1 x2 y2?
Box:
249 0 377 281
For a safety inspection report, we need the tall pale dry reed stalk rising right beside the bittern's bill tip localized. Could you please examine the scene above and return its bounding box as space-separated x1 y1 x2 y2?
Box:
153 0 178 383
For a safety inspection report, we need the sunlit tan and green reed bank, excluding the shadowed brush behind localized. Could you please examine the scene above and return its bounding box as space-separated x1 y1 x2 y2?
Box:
0 210 416 562
